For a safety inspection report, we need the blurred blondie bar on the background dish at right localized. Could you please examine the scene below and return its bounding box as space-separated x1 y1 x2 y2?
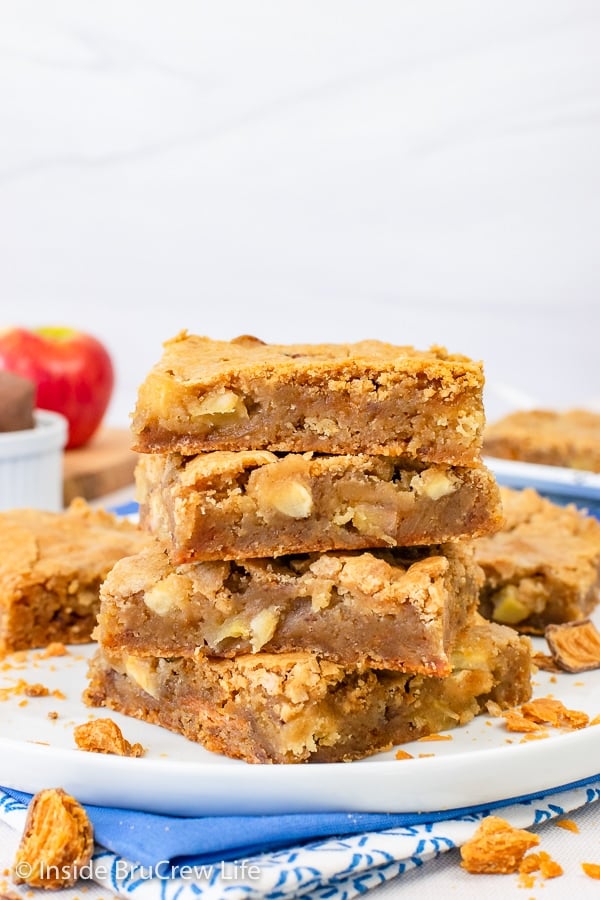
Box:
484 409 600 472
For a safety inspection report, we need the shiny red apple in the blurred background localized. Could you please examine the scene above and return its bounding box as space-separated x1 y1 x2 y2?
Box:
0 328 114 449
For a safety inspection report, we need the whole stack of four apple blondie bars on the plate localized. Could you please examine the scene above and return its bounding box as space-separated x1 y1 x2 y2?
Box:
86 333 530 763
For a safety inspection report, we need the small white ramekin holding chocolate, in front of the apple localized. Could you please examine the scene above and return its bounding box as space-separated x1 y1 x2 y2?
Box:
0 409 68 512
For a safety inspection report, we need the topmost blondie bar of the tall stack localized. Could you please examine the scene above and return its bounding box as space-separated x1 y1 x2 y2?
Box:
132 332 484 465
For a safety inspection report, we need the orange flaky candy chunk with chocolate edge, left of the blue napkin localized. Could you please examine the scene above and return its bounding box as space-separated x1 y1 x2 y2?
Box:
12 788 94 890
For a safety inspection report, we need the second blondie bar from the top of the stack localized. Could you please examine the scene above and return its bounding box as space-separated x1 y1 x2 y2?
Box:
135 450 502 563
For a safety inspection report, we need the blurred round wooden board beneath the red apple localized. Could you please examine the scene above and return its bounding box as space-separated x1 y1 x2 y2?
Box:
63 428 138 506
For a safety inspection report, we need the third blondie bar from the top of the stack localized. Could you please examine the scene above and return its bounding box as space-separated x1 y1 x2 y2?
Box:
95 542 481 675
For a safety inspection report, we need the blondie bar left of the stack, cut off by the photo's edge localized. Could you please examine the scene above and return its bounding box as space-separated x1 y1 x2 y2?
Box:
0 499 151 656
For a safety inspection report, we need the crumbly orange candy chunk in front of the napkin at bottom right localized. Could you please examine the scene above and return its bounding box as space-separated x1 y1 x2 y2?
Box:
460 816 540 875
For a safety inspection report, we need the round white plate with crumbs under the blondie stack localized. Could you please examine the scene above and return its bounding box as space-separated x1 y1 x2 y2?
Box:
0 624 600 815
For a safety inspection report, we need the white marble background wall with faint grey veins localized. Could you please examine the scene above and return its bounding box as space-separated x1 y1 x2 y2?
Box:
0 0 600 424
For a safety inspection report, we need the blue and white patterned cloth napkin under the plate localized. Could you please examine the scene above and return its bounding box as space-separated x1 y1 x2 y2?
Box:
0 775 600 900
